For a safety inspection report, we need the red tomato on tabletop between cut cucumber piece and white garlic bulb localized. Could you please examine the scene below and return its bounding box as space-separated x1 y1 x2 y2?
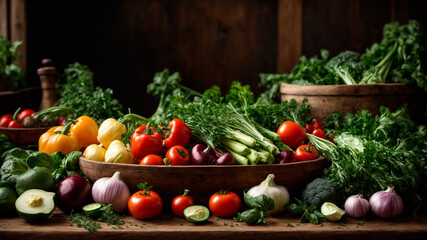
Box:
209 190 242 217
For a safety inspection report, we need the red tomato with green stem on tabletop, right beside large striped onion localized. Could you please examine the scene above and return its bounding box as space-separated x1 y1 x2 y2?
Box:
128 183 163 219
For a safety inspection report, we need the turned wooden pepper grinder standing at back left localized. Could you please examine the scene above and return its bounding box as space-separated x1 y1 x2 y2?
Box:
37 59 57 111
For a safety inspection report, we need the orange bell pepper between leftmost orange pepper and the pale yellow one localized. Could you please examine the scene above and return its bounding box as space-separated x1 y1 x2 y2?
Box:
70 116 99 147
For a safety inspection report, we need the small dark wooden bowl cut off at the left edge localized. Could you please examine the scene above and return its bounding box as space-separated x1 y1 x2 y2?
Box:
0 127 50 147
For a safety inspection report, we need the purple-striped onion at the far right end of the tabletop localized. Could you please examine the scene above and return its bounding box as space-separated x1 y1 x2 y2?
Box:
369 187 403 218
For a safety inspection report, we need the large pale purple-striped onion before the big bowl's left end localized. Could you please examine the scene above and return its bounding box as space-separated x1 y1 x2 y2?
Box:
92 171 130 212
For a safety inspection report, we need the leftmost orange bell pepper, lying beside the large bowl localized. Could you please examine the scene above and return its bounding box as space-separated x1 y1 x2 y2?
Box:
39 122 81 154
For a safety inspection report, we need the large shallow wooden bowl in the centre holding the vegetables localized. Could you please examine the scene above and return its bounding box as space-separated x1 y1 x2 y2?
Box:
80 157 326 204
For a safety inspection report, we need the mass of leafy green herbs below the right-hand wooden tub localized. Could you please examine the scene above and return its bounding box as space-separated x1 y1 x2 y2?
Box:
300 107 427 215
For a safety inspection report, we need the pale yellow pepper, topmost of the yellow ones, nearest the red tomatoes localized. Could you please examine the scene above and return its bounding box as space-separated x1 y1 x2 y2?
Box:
98 118 126 149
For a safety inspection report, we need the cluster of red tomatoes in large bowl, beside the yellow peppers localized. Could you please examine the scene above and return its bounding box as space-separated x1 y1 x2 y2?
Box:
131 119 191 165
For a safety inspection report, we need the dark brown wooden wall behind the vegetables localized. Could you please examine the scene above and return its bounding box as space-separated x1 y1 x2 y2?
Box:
27 0 427 116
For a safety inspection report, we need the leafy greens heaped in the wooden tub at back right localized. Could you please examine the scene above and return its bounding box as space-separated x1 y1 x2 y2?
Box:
260 20 427 99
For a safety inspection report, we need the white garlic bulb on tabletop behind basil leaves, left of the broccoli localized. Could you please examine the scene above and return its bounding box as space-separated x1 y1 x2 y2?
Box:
247 174 289 215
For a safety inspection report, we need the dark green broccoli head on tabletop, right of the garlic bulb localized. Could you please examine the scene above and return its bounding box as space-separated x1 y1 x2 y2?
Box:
302 178 338 209
